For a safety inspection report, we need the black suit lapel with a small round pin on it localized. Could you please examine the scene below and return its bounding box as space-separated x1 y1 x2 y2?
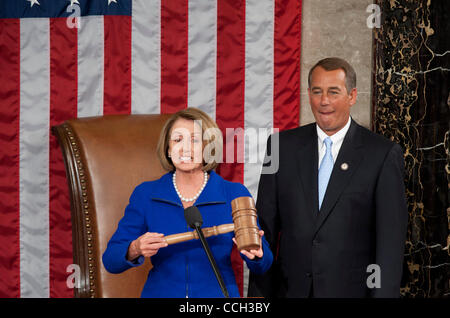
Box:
315 120 363 233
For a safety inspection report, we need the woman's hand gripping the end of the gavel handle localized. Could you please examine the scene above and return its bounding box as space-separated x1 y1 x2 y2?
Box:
127 232 167 260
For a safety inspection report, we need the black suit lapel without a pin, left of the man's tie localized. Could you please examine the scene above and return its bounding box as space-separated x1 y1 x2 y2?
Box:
296 125 319 220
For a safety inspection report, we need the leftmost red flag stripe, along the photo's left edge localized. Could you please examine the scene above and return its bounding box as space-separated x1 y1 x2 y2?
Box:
0 19 21 297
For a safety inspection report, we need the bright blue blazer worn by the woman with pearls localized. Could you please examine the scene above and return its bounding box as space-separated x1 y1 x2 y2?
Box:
103 171 273 298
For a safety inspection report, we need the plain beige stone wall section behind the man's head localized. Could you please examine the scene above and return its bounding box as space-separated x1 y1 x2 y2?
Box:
300 0 373 128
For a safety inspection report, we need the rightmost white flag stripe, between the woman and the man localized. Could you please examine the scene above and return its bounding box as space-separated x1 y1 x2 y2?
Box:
244 0 274 297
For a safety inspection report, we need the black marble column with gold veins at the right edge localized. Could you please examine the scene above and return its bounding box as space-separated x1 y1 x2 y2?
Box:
372 0 450 297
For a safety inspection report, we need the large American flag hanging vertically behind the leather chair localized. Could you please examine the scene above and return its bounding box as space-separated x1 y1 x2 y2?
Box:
0 0 301 297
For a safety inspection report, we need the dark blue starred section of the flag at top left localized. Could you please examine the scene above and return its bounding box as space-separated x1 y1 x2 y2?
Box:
0 0 131 19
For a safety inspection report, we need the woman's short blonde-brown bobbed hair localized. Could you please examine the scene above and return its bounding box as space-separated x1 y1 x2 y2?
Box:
156 107 223 172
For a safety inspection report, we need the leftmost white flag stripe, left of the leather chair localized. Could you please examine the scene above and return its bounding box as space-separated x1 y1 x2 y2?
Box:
19 18 50 297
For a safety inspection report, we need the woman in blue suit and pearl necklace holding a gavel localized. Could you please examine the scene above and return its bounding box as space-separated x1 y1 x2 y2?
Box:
103 108 273 297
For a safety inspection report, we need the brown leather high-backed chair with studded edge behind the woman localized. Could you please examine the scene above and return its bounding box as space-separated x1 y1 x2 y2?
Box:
52 115 170 297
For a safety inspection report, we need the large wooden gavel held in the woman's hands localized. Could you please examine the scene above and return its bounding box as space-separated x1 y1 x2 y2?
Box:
164 197 260 251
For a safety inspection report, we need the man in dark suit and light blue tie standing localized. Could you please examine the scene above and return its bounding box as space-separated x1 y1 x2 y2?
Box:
248 58 407 297
